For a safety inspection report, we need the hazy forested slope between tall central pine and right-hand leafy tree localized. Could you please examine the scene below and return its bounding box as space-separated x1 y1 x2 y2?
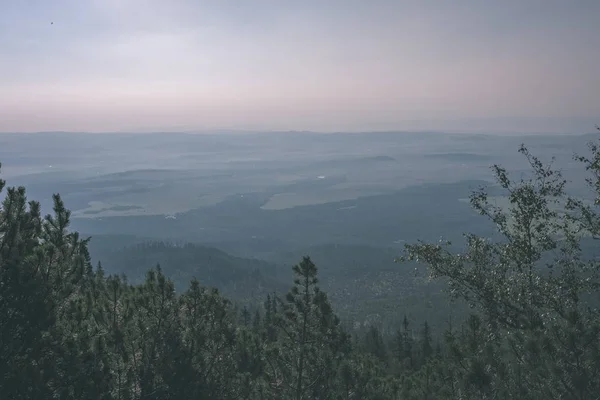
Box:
268 244 466 334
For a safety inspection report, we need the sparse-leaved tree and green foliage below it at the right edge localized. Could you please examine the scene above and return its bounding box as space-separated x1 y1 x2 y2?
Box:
406 126 600 399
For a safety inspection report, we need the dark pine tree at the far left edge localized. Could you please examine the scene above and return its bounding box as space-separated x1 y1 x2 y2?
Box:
0 173 55 399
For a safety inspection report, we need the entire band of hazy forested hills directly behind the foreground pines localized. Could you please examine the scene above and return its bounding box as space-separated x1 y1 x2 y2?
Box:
88 235 465 334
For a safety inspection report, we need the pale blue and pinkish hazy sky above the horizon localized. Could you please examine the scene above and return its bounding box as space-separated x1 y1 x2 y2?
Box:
0 0 600 133
